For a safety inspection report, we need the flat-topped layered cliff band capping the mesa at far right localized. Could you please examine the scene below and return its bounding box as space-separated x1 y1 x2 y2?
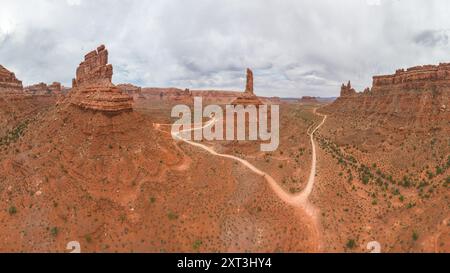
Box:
372 63 450 92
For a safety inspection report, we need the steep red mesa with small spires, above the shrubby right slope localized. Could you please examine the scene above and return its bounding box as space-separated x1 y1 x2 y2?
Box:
323 64 450 129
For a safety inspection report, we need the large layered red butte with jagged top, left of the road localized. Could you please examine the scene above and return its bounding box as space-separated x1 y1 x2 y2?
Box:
71 45 133 113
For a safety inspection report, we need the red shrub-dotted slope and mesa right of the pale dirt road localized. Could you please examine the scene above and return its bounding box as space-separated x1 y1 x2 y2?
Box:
313 64 450 252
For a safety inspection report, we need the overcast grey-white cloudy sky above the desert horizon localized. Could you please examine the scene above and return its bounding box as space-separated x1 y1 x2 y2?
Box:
0 0 450 97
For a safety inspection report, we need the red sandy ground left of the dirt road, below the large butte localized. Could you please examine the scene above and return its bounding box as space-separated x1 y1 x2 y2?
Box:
0 101 319 252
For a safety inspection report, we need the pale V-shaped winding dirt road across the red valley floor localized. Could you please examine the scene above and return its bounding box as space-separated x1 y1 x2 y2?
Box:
165 108 327 212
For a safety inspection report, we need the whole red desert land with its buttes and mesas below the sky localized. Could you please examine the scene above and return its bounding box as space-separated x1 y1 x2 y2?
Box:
0 45 450 252
